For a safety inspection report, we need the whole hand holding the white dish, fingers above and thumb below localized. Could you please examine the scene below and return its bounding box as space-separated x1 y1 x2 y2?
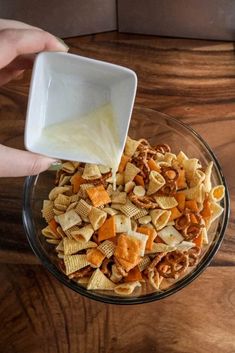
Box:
0 20 68 177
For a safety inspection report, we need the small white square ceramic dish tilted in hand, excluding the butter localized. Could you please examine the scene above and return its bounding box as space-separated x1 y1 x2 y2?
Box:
25 52 137 164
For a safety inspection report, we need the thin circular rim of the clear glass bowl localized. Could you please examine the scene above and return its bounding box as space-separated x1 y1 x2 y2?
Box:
22 105 230 305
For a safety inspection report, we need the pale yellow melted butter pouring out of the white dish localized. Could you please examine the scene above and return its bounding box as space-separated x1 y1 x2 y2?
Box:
41 104 122 189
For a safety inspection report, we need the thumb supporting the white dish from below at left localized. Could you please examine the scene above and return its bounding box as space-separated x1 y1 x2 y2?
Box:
0 145 56 177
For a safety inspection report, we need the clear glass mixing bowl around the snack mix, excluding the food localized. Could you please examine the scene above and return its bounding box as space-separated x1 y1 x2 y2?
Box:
23 107 229 304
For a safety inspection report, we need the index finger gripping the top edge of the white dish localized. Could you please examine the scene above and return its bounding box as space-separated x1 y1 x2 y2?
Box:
0 29 68 69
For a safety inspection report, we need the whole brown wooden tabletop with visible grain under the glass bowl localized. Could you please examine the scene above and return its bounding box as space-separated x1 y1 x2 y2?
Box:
0 32 235 353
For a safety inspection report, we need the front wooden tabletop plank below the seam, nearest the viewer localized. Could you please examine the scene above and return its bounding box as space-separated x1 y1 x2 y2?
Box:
0 265 235 353
